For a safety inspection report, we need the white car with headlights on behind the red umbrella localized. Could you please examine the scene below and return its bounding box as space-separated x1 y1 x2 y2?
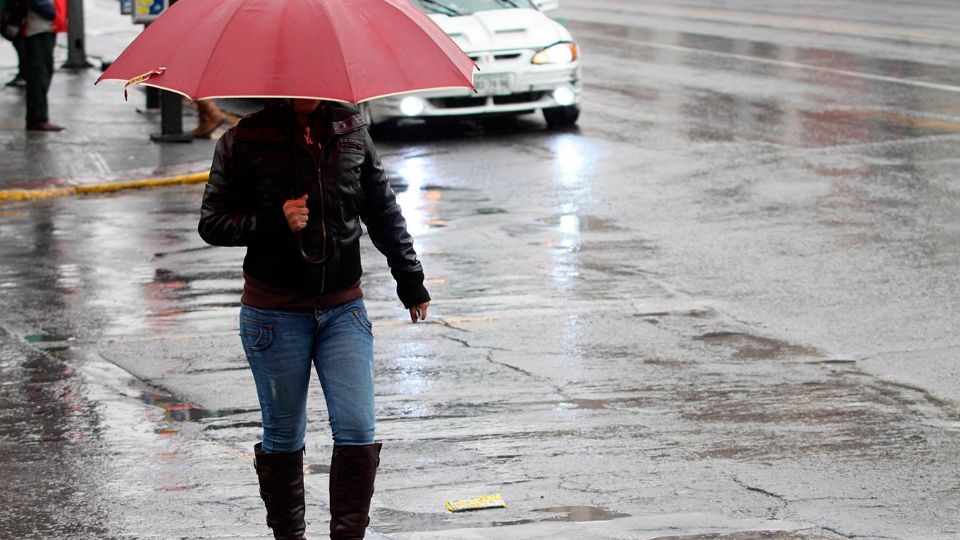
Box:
360 0 582 126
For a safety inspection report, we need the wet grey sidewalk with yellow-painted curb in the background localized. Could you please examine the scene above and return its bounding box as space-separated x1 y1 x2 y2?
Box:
0 0 232 200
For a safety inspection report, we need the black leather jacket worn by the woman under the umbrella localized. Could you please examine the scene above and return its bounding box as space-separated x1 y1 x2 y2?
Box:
199 102 430 308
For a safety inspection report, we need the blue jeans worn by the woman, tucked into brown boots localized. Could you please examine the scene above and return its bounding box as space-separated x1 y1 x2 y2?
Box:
240 298 376 452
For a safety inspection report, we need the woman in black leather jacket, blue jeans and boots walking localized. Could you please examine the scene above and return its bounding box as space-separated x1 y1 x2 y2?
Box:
199 99 430 539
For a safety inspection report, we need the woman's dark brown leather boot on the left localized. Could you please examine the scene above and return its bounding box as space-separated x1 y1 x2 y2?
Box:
253 443 307 540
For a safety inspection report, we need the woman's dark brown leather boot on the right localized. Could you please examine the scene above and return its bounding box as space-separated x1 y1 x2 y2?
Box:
330 443 383 540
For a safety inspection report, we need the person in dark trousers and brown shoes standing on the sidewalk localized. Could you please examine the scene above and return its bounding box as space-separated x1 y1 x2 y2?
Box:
21 0 67 131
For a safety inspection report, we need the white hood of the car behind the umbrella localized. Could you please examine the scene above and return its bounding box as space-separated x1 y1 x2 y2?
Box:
430 9 570 53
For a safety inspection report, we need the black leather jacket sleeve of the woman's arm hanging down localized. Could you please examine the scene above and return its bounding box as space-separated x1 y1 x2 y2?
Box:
360 131 430 308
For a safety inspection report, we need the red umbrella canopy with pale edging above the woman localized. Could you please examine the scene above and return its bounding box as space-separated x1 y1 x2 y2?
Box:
97 0 476 103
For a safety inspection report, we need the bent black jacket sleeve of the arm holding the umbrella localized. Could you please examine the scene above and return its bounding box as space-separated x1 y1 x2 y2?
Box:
198 133 290 246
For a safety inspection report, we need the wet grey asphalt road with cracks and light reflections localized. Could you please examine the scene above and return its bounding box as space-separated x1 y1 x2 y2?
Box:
0 0 960 539
